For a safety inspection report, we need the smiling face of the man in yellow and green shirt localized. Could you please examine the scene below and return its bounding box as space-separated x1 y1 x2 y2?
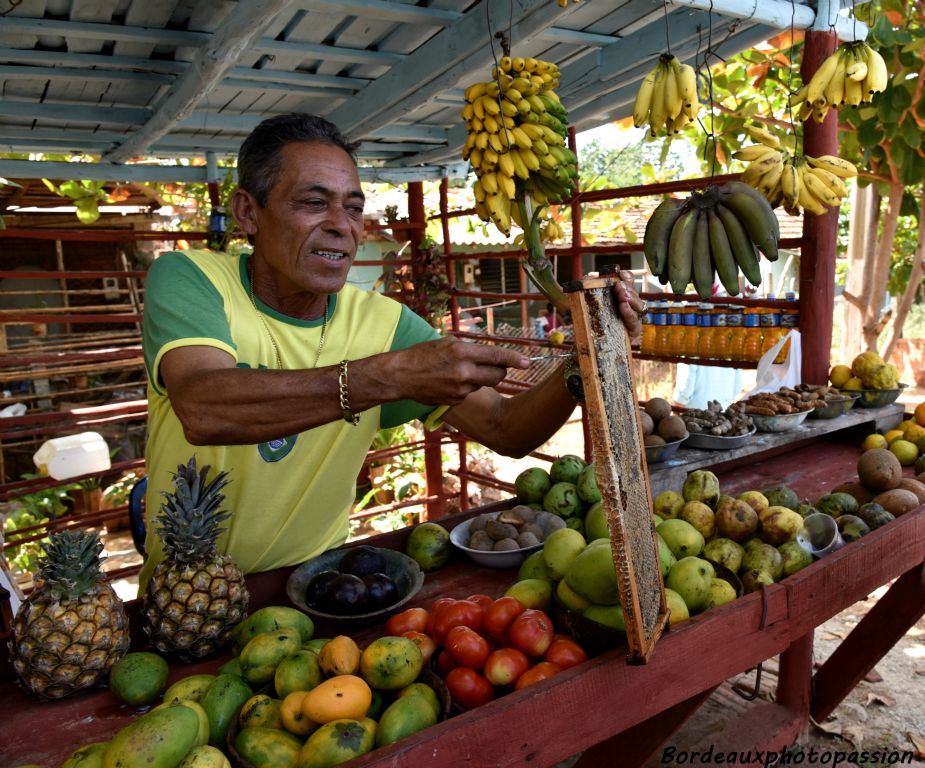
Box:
238 142 364 308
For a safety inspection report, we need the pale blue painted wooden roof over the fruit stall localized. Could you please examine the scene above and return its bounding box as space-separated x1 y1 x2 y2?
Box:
0 0 863 182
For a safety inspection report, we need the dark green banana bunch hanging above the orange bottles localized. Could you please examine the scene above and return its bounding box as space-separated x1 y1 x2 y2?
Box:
643 181 780 298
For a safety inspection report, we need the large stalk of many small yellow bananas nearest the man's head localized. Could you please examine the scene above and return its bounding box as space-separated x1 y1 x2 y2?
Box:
461 56 578 236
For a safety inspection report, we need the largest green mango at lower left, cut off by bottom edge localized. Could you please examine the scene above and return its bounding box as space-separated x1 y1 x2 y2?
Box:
103 704 199 768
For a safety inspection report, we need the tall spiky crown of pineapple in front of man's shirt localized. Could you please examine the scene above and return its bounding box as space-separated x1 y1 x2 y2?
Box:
157 456 231 563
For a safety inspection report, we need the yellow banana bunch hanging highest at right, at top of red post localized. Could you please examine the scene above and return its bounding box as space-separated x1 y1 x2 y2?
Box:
790 40 890 123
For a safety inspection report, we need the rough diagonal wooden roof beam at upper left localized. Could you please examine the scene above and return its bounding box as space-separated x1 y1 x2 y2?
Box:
104 0 298 163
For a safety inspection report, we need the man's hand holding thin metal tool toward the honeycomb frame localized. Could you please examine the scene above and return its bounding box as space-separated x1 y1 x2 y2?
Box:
384 338 530 405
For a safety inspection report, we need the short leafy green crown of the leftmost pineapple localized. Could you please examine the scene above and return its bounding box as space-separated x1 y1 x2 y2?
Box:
38 530 105 600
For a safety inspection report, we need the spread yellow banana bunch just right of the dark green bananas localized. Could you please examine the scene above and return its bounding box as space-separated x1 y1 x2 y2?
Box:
732 144 857 216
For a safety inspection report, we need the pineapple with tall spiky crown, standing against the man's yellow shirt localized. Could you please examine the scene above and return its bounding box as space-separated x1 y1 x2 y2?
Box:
143 456 248 659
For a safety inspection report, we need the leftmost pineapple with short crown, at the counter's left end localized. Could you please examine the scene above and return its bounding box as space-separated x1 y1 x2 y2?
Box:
9 530 129 699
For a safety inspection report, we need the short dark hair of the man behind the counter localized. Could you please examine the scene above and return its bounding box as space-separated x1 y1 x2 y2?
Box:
238 113 359 206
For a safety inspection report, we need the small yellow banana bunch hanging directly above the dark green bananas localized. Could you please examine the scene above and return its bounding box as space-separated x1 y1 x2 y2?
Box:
633 53 700 137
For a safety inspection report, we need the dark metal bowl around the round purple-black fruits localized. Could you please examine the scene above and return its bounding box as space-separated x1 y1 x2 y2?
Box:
286 547 424 626
